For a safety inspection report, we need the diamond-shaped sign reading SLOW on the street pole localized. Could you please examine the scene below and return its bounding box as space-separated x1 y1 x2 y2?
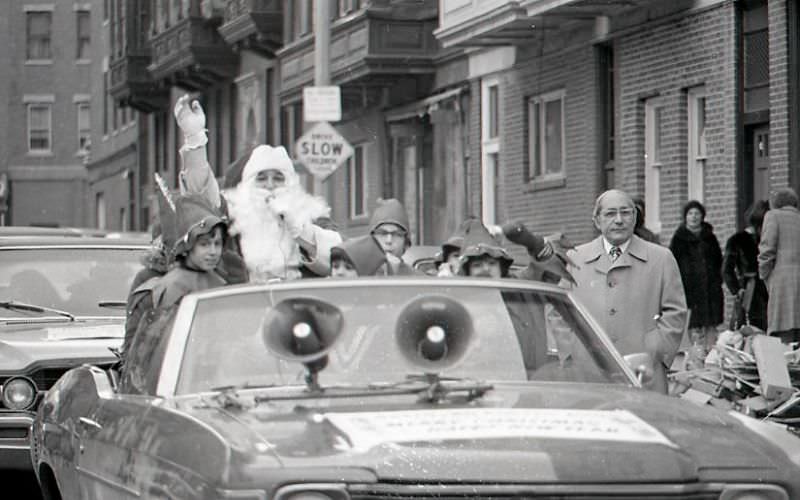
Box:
295 122 353 180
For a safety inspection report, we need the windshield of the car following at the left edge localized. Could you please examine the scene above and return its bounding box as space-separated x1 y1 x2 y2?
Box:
0 246 143 319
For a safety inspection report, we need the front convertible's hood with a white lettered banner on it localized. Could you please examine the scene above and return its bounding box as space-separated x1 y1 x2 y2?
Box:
175 384 787 483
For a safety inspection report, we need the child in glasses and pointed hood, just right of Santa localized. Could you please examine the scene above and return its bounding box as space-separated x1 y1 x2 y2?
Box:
369 198 415 276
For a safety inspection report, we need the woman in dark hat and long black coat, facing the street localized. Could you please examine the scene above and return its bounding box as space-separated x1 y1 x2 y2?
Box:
669 200 723 349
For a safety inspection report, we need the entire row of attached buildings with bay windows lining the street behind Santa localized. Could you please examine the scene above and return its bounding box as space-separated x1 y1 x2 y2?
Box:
83 0 800 250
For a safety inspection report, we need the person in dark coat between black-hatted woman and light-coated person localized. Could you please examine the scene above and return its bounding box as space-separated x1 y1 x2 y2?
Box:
722 200 769 332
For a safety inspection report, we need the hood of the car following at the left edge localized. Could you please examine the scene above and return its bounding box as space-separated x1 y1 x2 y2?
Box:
0 318 125 372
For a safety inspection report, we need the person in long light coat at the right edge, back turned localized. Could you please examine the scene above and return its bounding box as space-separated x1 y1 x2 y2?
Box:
758 188 800 342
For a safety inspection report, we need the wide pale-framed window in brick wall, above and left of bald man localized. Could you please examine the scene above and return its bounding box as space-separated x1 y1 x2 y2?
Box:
528 91 565 179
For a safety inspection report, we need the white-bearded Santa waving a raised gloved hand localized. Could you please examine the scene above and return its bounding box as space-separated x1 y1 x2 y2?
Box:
175 96 342 283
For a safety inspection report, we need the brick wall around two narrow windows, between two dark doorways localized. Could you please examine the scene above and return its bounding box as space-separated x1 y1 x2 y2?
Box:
615 2 738 244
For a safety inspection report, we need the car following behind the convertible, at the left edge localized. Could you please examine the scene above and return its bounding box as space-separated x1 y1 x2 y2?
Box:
0 234 149 469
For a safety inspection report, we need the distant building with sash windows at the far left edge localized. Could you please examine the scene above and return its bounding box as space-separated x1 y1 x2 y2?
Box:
0 0 93 226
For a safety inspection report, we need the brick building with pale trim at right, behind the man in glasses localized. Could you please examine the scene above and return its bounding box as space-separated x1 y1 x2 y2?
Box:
436 0 800 254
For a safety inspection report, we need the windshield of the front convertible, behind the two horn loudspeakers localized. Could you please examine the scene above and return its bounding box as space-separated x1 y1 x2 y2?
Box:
176 283 630 394
